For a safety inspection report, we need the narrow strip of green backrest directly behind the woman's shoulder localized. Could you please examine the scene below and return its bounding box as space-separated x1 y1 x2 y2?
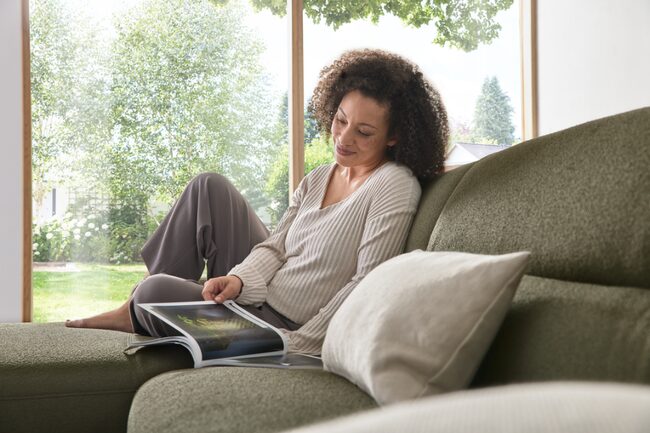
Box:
405 163 474 251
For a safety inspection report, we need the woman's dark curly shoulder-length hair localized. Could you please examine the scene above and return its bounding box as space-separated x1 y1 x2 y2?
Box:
309 49 449 180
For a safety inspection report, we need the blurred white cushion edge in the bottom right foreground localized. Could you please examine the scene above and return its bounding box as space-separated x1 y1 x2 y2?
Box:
284 382 650 433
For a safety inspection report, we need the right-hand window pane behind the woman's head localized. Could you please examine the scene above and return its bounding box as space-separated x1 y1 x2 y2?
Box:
304 0 521 169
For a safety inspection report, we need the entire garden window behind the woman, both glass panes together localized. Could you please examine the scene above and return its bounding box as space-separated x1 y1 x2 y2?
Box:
24 0 535 321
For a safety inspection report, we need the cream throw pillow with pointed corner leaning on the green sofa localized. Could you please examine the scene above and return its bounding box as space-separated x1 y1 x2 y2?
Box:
322 250 530 404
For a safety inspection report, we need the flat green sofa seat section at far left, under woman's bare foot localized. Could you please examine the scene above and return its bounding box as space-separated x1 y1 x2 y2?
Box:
0 323 191 433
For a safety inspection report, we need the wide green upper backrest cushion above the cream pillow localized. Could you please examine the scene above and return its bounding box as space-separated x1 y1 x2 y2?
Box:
428 108 650 288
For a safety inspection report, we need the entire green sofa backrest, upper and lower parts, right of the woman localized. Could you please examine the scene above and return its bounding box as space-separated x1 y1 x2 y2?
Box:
407 108 650 385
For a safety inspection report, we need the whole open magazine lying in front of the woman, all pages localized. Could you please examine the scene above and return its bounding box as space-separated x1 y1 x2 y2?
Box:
127 301 323 368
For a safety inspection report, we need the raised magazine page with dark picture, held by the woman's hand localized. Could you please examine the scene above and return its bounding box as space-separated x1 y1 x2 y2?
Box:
139 301 285 367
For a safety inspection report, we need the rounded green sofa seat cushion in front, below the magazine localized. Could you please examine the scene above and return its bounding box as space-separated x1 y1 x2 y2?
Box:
128 364 376 433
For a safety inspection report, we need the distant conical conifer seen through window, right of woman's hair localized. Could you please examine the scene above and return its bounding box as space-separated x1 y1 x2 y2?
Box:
474 77 515 145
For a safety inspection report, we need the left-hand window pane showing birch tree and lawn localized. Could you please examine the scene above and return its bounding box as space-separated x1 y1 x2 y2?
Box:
30 0 288 321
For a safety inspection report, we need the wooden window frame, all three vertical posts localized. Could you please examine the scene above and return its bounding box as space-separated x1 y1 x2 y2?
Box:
22 0 538 322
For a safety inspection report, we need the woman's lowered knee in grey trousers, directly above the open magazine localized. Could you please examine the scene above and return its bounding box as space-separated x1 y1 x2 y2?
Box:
133 274 202 304
